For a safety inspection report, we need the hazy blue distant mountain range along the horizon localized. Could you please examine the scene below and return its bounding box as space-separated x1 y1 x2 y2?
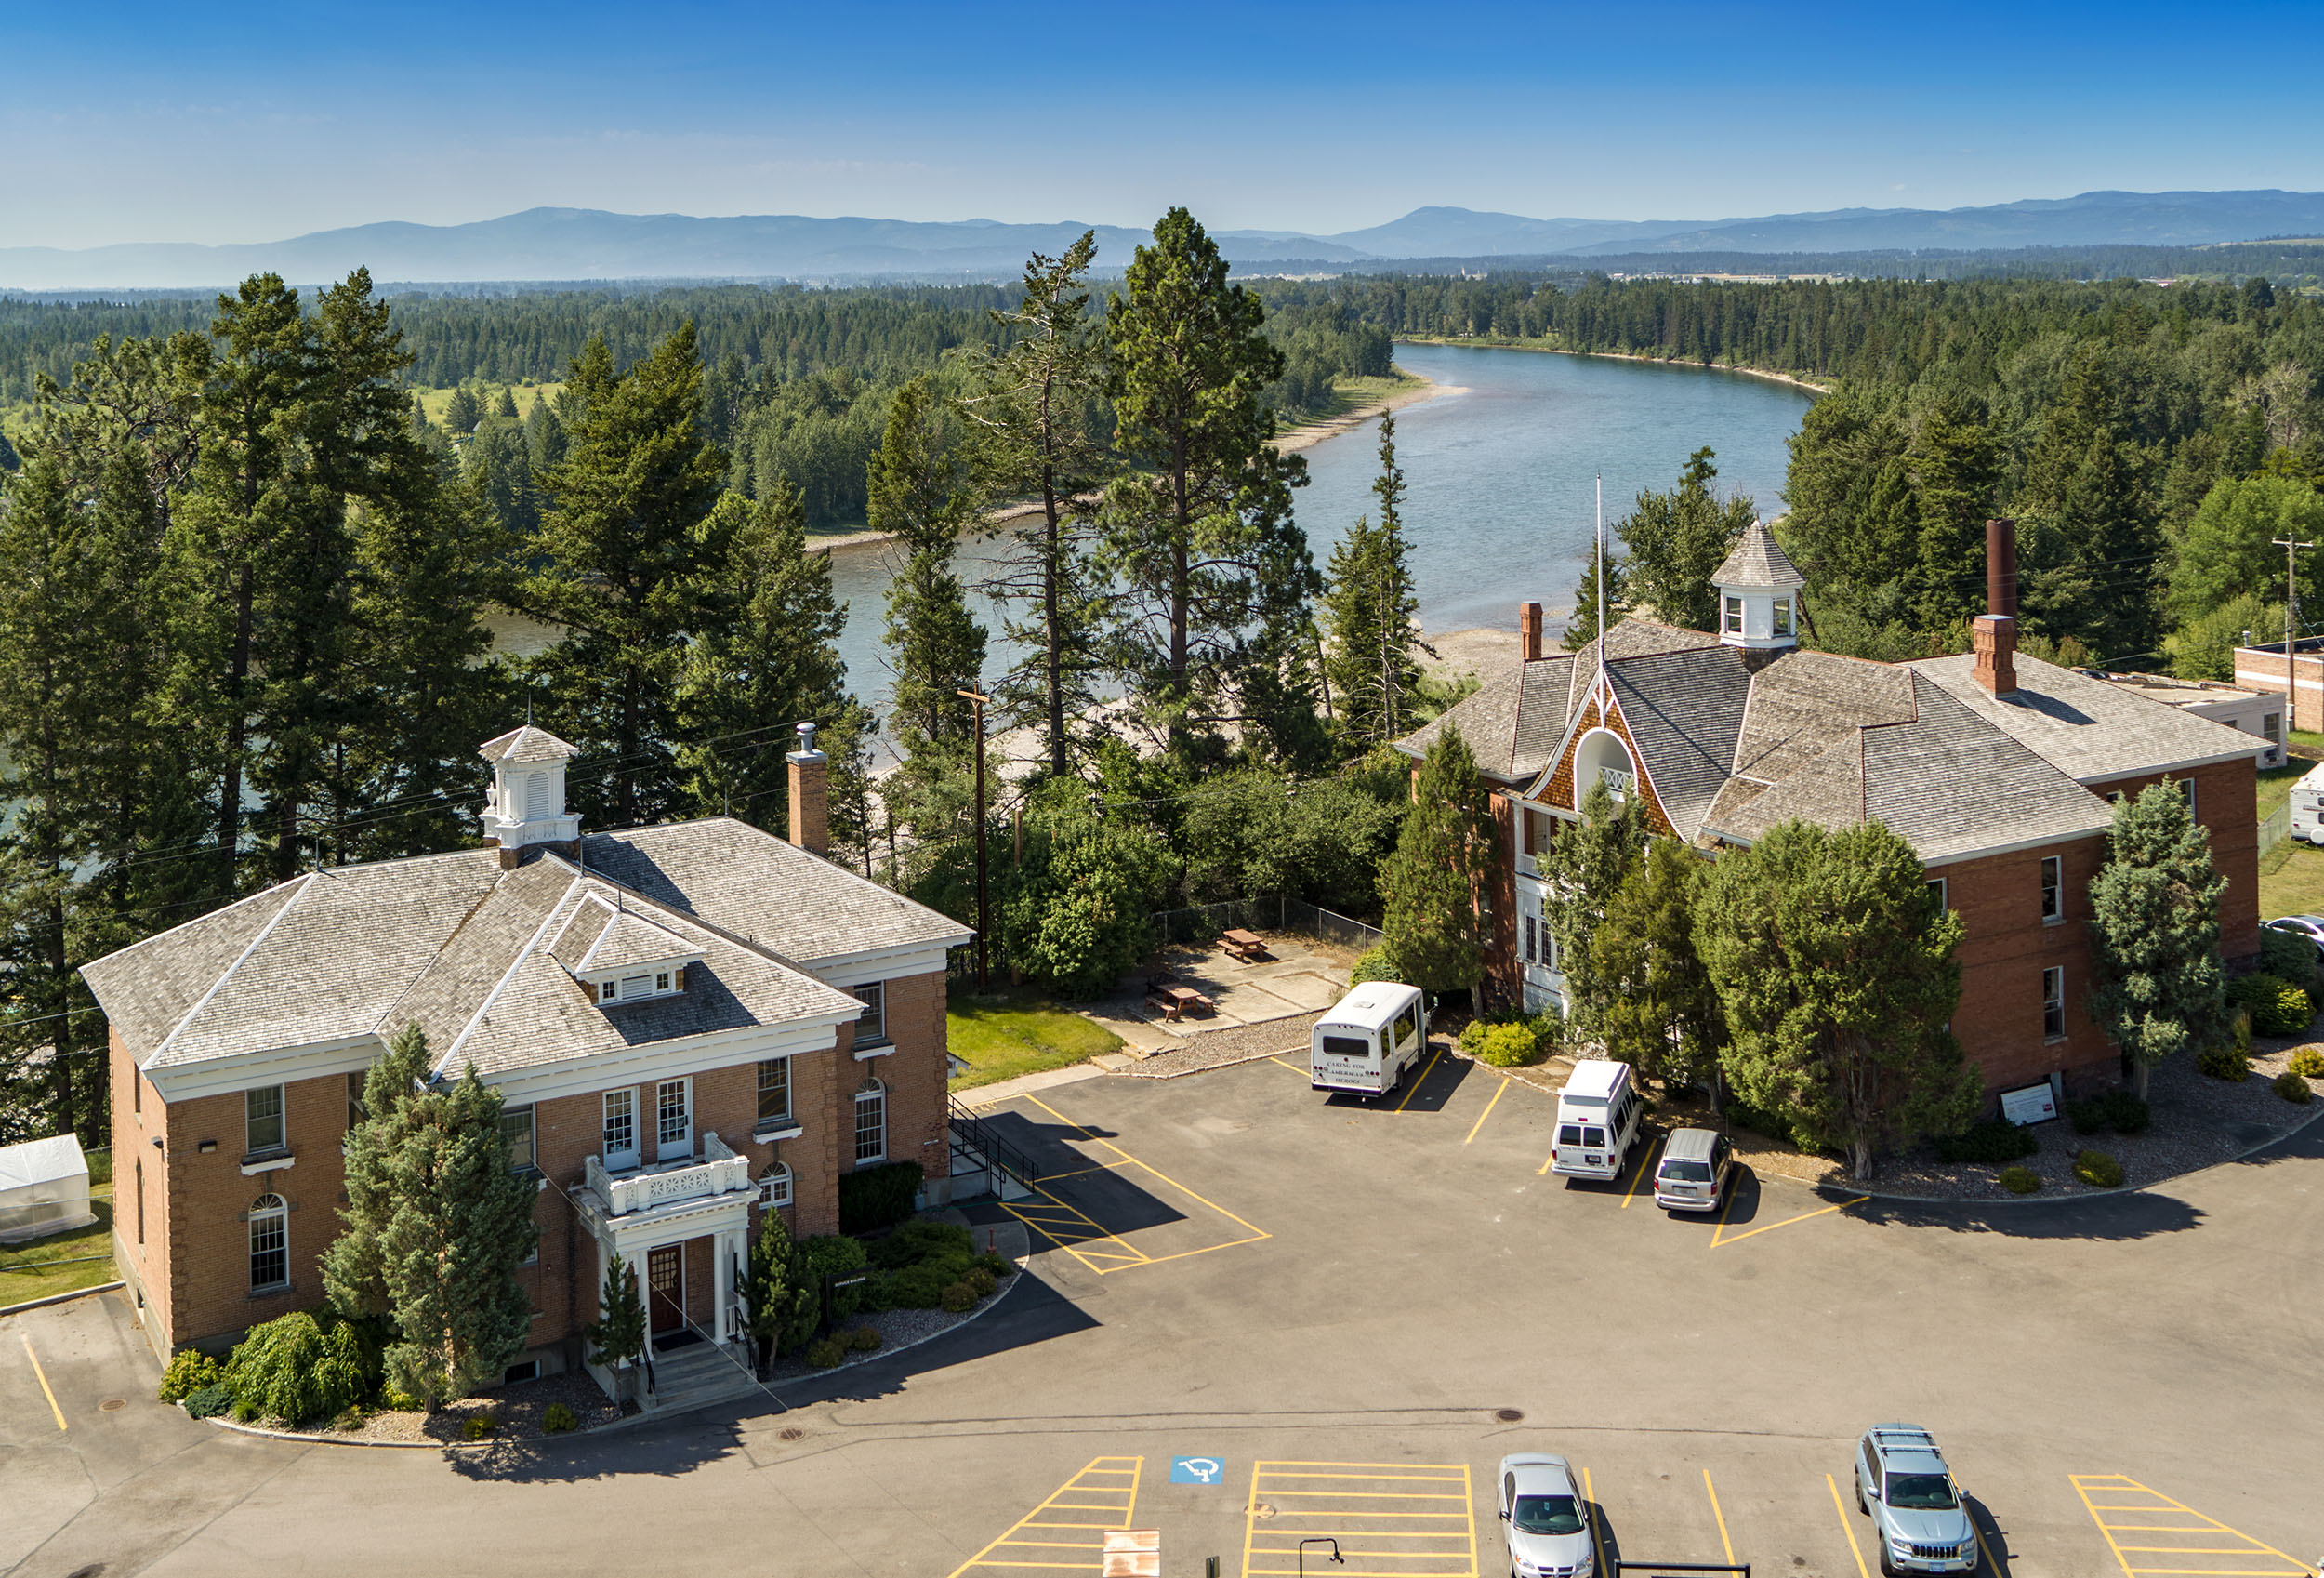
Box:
13 191 2324 290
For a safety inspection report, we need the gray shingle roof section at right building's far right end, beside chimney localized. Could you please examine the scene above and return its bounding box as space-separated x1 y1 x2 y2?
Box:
1904 653 2268 783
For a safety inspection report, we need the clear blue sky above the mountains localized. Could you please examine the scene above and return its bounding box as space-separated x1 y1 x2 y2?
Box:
0 0 2324 246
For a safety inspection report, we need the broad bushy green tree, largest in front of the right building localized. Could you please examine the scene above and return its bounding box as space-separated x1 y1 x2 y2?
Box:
1695 823 1983 1181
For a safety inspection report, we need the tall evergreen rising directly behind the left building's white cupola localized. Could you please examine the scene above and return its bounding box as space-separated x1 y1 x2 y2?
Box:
514 321 728 828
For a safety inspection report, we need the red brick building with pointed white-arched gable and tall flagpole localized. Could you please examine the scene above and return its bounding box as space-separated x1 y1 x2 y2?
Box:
1402 521 2271 1110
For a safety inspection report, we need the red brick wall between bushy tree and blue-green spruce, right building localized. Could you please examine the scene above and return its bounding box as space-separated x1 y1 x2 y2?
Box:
1932 837 2119 1093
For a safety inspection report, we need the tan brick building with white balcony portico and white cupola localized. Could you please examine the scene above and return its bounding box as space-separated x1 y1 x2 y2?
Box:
84 725 967 1403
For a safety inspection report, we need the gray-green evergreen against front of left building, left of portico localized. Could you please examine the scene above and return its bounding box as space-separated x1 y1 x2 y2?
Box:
324 1025 542 1411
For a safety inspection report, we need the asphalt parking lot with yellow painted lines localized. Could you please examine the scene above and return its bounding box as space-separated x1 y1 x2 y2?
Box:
0 1057 2324 1578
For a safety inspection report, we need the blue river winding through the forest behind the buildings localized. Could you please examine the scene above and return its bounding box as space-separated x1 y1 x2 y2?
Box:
497 344 1811 709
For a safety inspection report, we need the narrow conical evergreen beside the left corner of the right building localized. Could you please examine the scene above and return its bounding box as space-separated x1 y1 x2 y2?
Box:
1380 727 1499 995
